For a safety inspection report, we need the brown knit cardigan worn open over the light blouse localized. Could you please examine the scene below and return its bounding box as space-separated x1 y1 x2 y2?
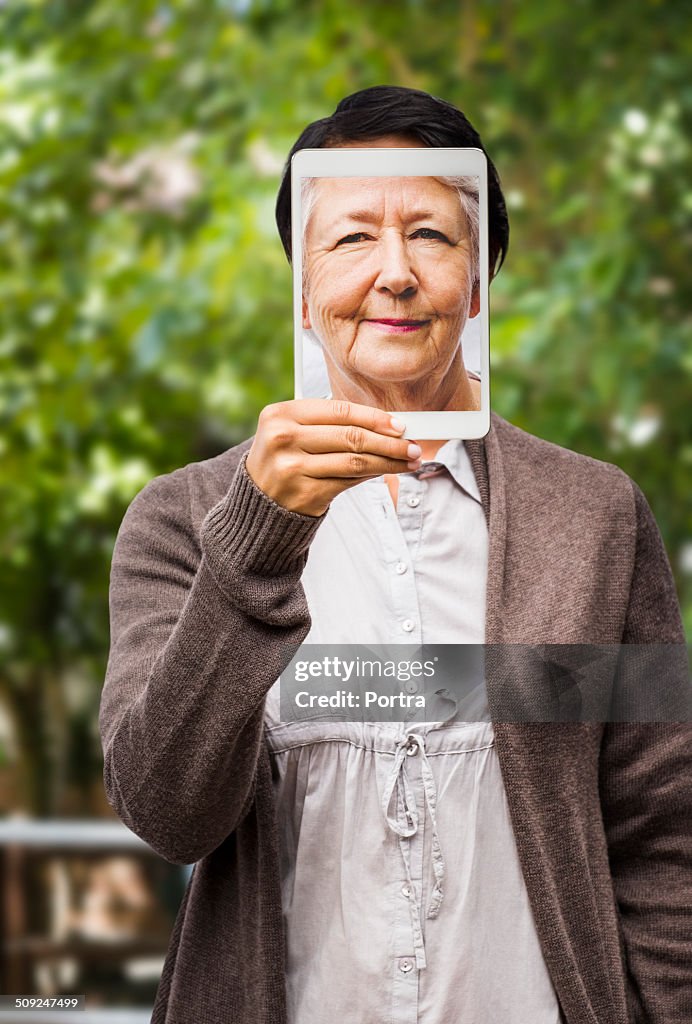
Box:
100 415 692 1024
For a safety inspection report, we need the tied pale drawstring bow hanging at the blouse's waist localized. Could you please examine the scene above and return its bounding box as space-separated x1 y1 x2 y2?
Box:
382 733 444 970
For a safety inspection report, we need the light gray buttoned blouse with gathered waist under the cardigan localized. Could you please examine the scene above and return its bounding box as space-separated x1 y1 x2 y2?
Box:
265 440 562 1024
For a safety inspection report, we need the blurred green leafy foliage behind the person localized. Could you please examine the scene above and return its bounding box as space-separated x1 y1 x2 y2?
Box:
0 0 692 814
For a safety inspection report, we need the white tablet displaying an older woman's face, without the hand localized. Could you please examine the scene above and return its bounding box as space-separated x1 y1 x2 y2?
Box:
291 146 490 439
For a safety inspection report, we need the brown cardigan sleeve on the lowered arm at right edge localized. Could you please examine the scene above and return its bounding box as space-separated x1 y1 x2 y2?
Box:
600 484 692 1024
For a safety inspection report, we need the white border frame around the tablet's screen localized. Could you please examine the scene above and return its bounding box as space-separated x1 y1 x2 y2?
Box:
291 146 490 439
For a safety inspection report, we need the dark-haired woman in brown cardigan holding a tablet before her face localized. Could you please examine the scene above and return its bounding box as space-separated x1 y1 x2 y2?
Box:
101 87 692 1024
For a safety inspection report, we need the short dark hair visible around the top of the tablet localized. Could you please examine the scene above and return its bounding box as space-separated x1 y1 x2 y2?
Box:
276 85 510 276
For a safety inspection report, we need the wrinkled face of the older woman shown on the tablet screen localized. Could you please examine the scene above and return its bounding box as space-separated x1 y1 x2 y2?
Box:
303 177 478 386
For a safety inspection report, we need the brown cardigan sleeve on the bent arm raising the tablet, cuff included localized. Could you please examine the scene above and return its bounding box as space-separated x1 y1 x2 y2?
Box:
99 456 323 863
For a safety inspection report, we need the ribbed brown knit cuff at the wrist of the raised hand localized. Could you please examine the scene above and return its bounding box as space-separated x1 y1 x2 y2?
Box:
202 452 327 577
